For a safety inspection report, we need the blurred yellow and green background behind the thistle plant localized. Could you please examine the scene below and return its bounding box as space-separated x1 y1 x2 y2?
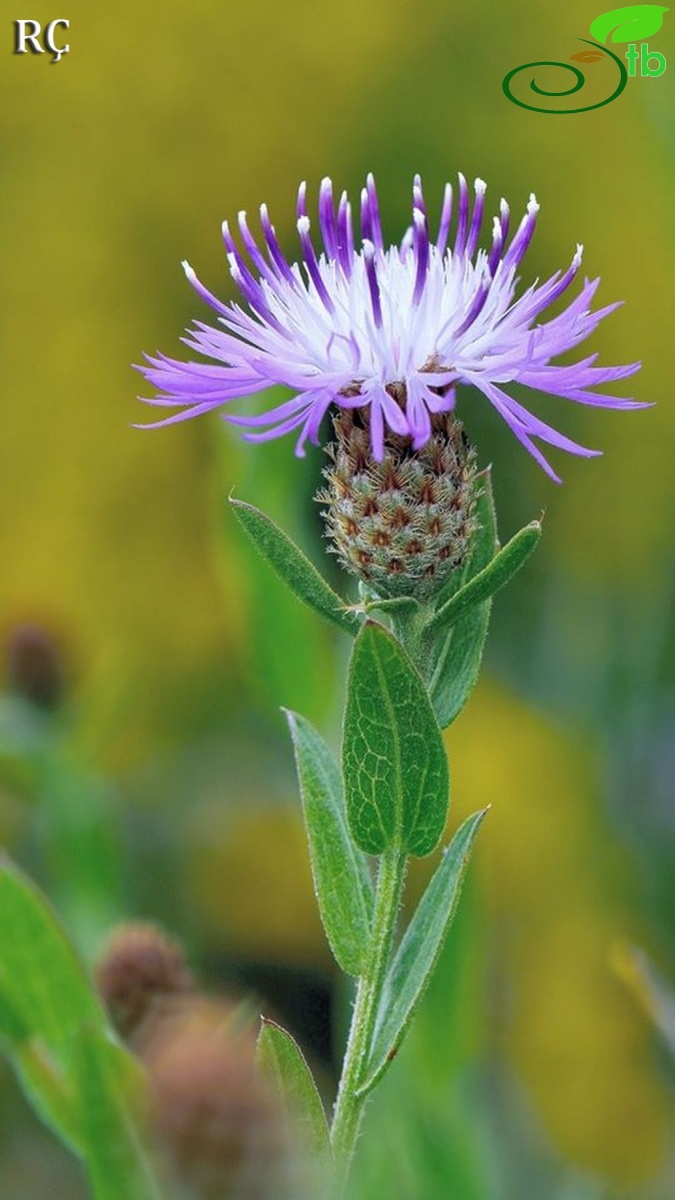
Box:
0 0 675 1200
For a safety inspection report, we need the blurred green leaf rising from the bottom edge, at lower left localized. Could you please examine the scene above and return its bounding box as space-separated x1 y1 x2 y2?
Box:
77 1027 160 1200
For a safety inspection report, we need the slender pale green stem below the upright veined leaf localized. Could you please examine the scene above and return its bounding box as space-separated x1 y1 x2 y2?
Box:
330 845 407 1181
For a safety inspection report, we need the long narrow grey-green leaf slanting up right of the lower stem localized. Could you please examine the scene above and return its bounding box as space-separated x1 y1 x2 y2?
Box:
358 809 488 1096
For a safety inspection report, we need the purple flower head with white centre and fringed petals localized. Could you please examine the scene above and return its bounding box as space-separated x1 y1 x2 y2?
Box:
139 175 645 480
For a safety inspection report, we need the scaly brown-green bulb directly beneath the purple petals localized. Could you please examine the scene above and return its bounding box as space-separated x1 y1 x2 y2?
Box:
317 409 477 600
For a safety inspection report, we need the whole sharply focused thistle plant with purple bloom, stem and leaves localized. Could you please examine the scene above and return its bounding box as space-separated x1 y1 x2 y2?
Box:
132 175 641 1184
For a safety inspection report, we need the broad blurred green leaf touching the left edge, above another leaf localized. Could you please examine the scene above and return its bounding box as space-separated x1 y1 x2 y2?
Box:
0 859 107 1151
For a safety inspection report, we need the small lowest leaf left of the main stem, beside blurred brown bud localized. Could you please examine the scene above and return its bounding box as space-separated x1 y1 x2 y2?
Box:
257 1018 330 1158
